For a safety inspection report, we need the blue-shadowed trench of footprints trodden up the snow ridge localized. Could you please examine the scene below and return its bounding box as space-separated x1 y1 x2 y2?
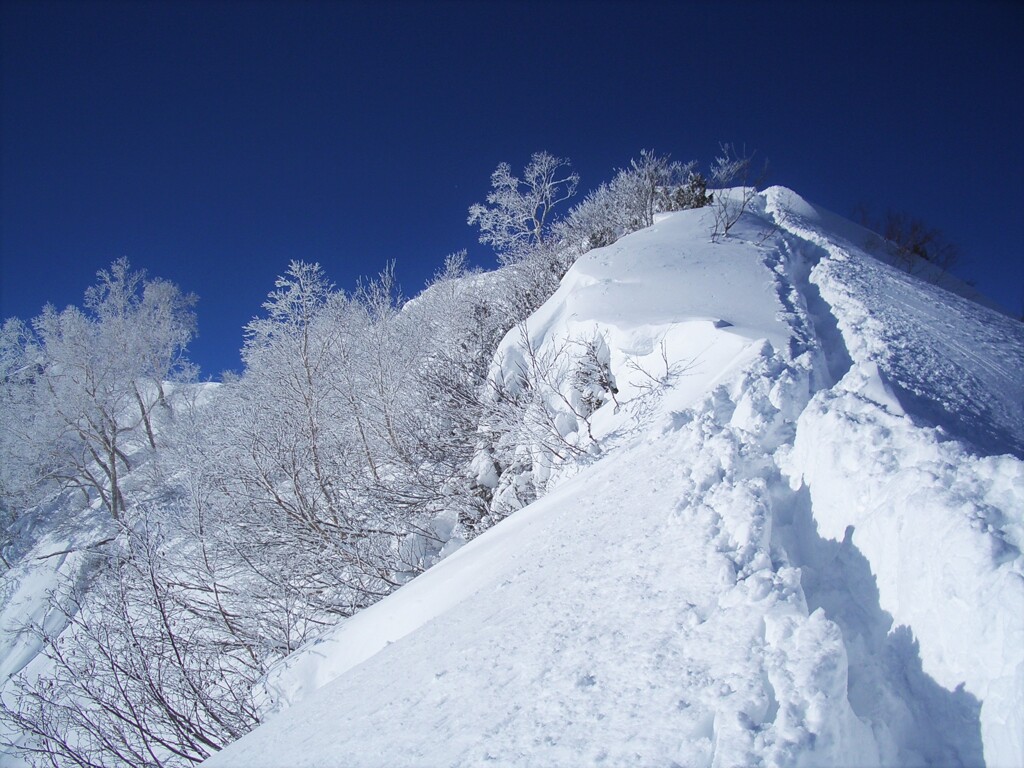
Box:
766 233 984 765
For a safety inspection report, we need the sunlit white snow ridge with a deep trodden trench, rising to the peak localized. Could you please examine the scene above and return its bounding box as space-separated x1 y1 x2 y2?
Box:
208 188 1024 766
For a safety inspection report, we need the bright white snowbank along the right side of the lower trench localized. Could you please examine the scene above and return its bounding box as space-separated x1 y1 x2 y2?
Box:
790 367 1024 766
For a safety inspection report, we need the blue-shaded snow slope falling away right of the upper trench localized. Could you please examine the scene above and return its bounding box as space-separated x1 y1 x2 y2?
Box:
765 187 1024 458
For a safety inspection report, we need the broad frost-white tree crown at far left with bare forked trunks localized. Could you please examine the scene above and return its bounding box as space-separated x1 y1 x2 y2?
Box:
4 259 196 519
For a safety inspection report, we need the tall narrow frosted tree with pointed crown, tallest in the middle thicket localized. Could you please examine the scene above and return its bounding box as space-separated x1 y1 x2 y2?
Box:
227 262 393 618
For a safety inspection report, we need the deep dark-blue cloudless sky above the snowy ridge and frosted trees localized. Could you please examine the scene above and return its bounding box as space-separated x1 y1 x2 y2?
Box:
0 0 1024 376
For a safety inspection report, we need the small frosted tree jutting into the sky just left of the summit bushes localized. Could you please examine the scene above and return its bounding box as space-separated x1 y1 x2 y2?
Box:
468 152 580 263
